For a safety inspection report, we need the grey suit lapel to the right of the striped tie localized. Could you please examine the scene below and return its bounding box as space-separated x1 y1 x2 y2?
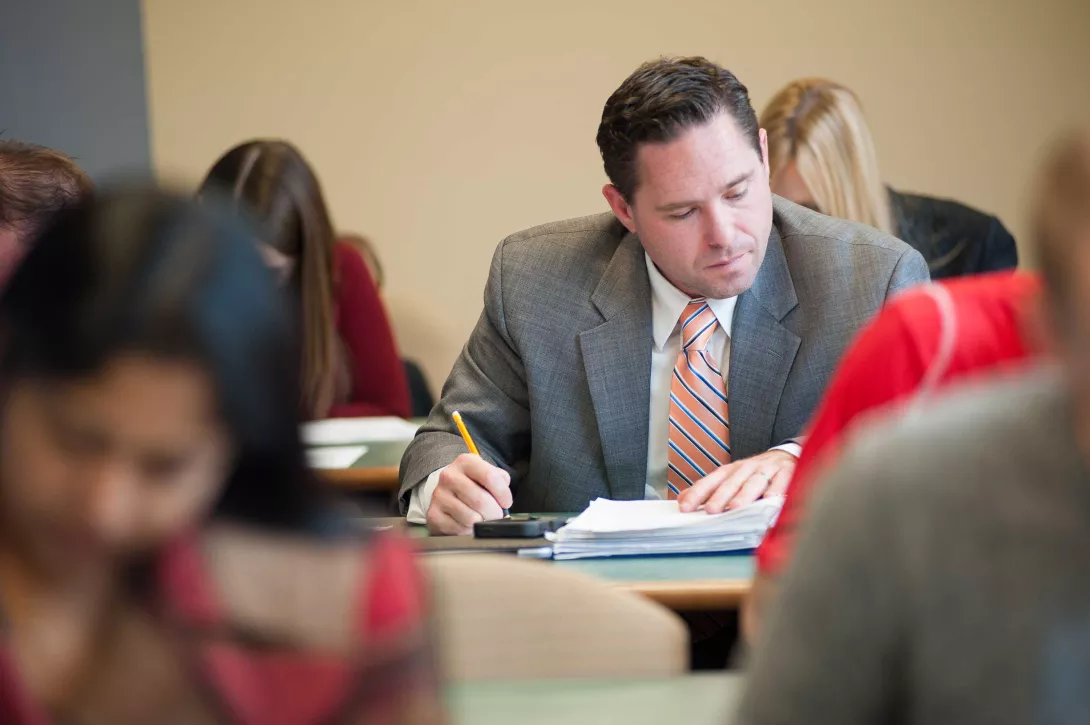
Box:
728 226 801 460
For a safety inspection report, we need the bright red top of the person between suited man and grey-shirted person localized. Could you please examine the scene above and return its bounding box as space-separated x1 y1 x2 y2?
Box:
758 273 1040 575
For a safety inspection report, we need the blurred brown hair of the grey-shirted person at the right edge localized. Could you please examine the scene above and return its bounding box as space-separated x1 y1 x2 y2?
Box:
1031 126 1090 313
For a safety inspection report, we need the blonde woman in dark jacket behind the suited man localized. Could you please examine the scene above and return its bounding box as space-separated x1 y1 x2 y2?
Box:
761 78 1018 279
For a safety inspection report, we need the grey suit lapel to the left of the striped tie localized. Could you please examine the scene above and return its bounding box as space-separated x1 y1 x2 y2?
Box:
579 234 652 499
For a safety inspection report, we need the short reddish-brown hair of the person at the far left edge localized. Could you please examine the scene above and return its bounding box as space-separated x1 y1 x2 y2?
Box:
0 140 92 240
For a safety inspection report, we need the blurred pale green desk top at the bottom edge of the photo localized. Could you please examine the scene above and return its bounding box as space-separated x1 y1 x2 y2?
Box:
447 673 742 725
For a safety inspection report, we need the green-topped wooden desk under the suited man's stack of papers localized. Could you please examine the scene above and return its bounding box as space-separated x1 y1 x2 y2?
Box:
390 515 755 612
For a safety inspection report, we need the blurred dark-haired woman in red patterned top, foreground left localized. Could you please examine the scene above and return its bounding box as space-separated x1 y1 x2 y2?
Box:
0 191 445 725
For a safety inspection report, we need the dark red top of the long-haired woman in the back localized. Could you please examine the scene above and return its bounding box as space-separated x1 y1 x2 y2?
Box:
329 242 412 418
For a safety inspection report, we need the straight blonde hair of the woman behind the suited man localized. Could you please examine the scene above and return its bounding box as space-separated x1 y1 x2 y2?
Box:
761 78 895 234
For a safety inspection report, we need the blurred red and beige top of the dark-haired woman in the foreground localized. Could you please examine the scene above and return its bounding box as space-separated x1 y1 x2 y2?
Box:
0 525 446 725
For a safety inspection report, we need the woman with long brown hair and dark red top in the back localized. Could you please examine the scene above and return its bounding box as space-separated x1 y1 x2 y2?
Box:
201 140 410 419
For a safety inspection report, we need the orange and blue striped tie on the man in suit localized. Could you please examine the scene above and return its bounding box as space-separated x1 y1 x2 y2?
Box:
666 298 730 498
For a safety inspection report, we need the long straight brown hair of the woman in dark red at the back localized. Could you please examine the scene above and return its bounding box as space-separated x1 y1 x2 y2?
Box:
201 140 348 418
